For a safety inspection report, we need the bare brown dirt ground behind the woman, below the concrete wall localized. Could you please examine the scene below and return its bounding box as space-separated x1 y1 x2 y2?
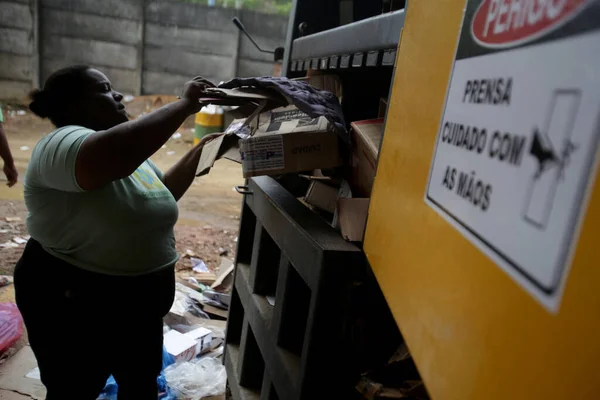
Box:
0 96 244 275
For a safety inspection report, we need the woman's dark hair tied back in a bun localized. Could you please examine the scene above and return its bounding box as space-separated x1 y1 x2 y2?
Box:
29 65 91 126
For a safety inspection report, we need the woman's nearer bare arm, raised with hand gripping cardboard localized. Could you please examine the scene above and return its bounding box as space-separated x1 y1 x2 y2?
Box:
75 78 207 190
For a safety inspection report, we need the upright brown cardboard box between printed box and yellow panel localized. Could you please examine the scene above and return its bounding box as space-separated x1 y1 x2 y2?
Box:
351 119 384 197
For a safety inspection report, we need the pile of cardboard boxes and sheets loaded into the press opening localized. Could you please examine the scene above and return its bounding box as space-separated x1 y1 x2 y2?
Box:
196 75 387 242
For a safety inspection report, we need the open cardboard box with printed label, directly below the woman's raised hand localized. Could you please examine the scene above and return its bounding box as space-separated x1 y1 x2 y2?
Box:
196 106 342 178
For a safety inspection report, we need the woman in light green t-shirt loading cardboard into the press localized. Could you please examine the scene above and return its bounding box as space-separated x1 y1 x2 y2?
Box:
15 66 219 400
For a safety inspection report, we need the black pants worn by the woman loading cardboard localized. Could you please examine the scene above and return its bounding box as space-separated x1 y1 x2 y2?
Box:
15 239 175 400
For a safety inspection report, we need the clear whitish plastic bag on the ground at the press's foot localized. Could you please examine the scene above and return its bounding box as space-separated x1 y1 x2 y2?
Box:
165 357 227 400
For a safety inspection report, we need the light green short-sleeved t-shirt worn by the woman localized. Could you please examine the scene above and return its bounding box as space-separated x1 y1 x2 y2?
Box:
24 126 178 275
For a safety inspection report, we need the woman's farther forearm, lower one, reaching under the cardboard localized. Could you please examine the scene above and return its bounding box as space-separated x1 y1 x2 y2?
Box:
163 133 222 201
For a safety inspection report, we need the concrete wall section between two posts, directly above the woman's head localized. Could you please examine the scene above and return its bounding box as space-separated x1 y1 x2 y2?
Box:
40 0 144 93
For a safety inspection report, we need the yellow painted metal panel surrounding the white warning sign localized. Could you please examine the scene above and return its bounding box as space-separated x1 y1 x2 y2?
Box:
365 0 600 400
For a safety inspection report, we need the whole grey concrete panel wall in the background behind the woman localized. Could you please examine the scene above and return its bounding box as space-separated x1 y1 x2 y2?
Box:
0 0 287 99
